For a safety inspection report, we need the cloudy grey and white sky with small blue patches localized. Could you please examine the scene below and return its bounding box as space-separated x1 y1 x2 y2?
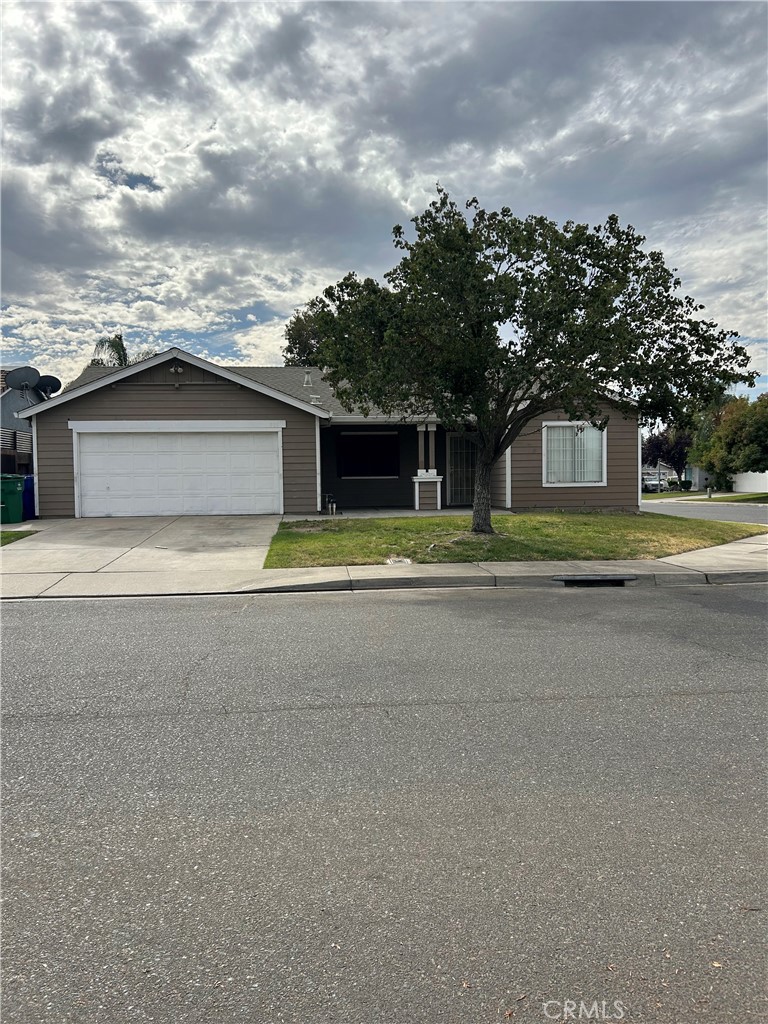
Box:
2 0 768 390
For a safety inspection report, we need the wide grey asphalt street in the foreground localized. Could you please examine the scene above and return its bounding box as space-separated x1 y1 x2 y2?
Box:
2 586 766 1024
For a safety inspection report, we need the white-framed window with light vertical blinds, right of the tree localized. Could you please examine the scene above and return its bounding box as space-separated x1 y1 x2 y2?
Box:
542 420 608 487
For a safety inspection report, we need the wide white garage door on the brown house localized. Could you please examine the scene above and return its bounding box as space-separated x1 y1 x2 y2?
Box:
78 431 282 517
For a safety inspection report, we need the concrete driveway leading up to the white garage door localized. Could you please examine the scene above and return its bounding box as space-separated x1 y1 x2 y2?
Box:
0 515 281 597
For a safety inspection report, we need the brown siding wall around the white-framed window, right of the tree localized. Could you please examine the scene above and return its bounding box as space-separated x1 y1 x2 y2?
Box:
511 410 638 509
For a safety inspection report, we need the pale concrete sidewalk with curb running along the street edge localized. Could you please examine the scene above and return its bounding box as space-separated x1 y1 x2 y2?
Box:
2 535 768 599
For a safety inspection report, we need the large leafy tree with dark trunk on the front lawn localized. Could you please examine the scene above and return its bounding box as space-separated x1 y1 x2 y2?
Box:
285 186 752 532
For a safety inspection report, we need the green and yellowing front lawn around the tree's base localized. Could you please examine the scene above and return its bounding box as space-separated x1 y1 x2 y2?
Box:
265 512 766 568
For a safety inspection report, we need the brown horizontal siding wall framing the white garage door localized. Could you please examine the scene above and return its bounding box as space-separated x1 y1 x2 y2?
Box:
37 374 317 517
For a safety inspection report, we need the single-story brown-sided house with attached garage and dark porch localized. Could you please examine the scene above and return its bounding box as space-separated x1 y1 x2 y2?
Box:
20 348 639 517
